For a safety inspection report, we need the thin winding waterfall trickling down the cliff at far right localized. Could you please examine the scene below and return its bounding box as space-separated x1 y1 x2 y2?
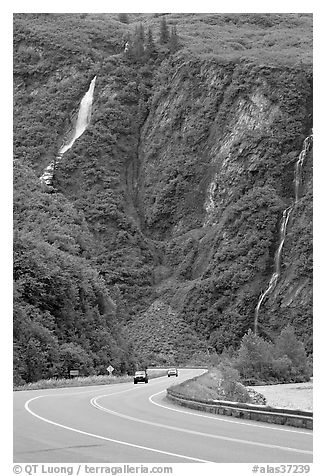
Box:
254 133 313 334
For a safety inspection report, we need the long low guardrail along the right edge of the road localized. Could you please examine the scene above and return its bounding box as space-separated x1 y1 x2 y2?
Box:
167 388 313 430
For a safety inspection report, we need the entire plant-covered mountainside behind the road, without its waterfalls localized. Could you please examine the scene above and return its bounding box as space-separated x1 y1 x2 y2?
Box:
14 14 312 383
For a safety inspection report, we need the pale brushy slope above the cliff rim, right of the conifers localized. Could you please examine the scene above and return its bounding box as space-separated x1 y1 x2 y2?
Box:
87 13 313 65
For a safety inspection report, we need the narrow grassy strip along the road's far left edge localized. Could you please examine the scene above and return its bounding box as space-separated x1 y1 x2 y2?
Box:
13 370 166 392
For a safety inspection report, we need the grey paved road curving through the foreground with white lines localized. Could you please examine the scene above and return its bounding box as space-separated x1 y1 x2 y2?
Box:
14 369 312 463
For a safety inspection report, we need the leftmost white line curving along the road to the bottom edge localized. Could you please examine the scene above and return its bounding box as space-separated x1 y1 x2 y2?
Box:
25 392 213 463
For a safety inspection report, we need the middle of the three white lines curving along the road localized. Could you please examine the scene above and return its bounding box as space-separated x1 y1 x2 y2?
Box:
90 390 312 454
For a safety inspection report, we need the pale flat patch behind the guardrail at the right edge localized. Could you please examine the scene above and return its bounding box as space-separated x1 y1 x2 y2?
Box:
248 381 313 411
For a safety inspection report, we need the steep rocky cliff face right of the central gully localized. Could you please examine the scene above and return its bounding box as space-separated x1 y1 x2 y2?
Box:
131 59 312 350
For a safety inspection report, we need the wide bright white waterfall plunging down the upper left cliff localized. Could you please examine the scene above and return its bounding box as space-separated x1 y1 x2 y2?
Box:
40 76 96 185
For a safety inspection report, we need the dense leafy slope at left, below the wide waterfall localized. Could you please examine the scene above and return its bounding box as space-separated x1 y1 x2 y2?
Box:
14 163 133 383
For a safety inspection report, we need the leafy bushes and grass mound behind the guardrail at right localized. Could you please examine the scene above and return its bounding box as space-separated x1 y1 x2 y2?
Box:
173 326 311 404
